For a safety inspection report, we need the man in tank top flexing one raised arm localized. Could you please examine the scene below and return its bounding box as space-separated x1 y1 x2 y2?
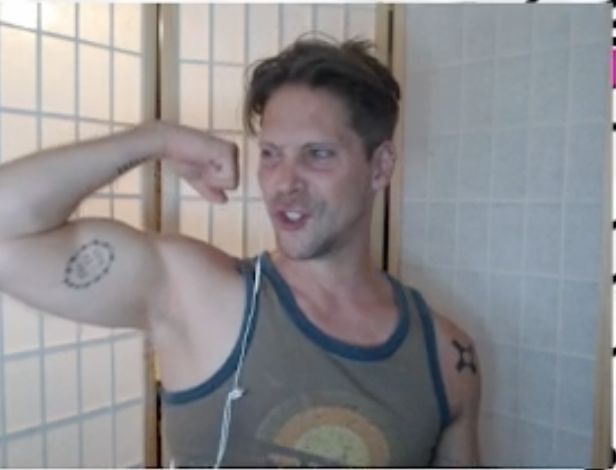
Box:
0 40 480 466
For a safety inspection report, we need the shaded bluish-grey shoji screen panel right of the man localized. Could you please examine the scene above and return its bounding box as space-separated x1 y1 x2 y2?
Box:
401 5 611 467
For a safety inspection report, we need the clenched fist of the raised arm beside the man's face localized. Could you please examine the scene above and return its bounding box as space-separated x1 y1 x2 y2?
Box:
157 122 239 202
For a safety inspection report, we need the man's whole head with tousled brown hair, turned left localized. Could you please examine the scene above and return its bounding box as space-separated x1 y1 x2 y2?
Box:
244 40 400 259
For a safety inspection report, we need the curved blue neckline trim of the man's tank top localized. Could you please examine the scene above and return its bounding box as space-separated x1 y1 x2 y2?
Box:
263 253 410 361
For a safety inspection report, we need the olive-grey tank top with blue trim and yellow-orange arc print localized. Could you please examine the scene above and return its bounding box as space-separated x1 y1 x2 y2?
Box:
161 254 450 467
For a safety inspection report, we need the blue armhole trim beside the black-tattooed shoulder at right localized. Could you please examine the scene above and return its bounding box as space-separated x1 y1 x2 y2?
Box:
412 289 451 430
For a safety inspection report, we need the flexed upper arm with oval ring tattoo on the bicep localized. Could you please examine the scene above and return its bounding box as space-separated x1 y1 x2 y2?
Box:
0 219 163 329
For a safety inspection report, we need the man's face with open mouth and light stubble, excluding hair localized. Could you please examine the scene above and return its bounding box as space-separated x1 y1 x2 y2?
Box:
259 86 374 259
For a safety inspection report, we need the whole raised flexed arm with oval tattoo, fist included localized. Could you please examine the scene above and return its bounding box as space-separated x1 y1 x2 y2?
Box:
0 123 237 329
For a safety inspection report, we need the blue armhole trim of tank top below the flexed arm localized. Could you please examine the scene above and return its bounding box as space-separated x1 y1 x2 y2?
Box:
160 255 259 405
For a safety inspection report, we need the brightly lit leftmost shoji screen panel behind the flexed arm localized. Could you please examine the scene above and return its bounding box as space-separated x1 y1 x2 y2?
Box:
0 2 156 467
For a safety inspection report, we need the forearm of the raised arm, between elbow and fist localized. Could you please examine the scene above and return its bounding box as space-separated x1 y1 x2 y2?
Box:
0 123 163 240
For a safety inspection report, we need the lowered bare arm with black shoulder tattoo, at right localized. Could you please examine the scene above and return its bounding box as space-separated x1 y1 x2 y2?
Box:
433 315 481 467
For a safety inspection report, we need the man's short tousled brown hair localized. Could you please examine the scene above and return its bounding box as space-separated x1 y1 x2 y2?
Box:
243 38 400 157
